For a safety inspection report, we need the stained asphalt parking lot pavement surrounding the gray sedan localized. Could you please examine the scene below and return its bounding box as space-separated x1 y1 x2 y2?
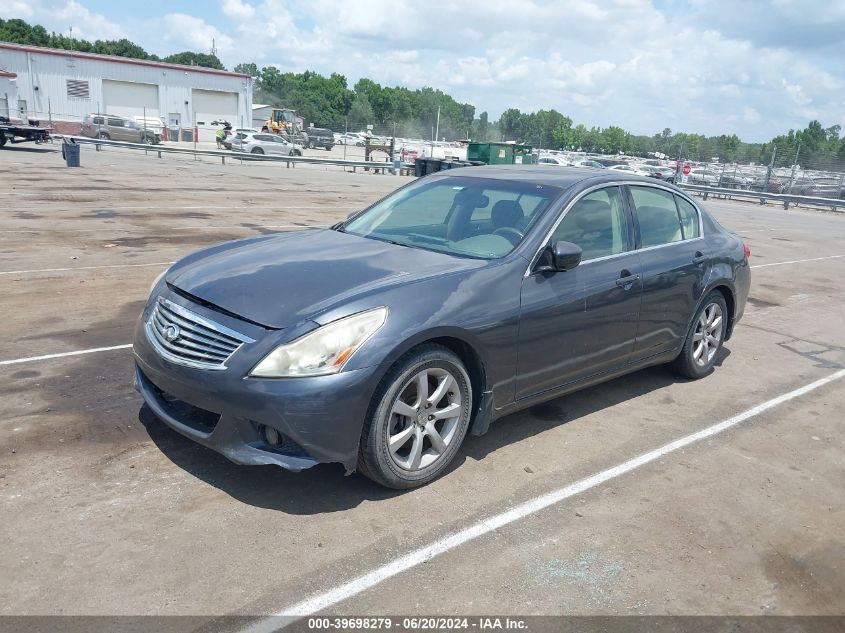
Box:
0 143 845 615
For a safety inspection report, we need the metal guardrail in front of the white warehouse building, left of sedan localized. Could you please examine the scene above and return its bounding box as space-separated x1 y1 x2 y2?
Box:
58 135 413 173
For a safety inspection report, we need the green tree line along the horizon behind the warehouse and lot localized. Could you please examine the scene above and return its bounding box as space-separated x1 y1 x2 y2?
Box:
0 19 845 169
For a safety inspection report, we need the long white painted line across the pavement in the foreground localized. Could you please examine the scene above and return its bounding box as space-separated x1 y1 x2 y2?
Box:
236 369 845 633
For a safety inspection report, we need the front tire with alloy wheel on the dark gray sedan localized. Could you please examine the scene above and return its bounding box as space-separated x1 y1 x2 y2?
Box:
358 345 472 490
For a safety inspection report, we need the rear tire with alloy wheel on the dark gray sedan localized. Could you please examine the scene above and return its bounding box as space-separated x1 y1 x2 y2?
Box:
671 290 728 380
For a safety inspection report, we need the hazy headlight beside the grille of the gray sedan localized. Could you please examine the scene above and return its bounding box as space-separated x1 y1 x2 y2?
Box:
249 308 387 378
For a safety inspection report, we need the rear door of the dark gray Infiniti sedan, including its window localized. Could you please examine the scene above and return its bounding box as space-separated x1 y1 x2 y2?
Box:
628 185 710 359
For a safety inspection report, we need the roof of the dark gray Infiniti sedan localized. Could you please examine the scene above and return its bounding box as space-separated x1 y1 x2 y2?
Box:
437 165 671 189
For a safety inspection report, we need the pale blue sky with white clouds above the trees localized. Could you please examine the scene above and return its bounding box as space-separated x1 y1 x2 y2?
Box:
0 0 845 142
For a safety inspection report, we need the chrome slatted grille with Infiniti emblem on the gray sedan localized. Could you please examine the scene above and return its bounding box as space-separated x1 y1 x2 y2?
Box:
147 297 254 369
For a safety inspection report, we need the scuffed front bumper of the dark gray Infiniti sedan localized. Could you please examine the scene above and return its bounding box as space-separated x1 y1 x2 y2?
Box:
133 295 380 472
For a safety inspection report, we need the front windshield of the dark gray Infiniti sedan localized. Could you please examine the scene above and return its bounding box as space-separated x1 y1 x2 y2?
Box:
340 176 560 259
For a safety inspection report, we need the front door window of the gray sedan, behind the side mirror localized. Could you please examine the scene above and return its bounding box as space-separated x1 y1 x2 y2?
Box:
552 187 628 261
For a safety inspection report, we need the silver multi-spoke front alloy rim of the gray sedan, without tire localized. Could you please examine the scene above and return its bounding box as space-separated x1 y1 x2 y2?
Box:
387 367 463 471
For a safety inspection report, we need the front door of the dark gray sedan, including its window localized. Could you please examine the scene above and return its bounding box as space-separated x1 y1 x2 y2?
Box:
516 187 642 399
